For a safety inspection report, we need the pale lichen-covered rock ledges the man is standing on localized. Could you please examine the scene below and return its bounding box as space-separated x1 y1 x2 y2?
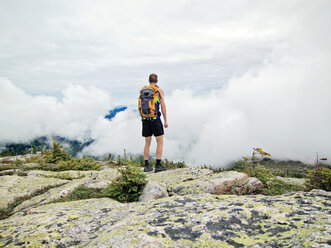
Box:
0 164 331 247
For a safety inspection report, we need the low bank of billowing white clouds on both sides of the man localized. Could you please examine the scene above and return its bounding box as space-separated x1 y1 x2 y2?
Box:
0 40 331 167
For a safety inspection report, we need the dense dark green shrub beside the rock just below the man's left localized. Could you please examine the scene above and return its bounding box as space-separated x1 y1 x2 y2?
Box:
104 165 147 202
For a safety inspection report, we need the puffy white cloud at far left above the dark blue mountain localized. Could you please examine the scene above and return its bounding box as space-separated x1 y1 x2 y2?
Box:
0 78 112 143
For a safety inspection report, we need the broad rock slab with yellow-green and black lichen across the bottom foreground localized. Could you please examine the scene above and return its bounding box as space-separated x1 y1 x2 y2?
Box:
0 191 331 247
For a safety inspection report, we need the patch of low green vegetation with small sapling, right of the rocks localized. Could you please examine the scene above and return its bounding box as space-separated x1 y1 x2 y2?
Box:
231 148 331 195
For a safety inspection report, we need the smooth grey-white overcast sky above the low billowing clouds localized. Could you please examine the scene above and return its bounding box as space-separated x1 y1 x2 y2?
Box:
0 0 308 104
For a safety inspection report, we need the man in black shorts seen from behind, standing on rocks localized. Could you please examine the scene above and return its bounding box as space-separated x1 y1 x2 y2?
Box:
139 74 168 173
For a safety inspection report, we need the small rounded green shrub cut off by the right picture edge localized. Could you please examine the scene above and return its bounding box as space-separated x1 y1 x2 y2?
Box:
306 167 331 191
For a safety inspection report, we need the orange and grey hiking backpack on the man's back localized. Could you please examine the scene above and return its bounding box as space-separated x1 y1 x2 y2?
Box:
138 85 161 119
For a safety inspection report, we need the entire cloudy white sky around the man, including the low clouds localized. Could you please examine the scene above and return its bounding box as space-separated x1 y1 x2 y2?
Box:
0 0 331 165
